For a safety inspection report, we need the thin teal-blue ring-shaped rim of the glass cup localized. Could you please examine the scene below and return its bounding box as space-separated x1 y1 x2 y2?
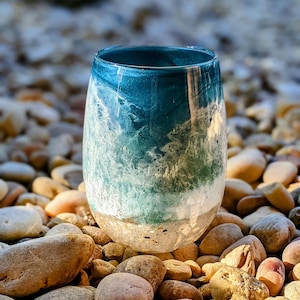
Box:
94 46 218 70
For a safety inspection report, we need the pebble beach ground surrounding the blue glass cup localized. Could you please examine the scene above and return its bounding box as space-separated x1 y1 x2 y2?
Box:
0 0 300 300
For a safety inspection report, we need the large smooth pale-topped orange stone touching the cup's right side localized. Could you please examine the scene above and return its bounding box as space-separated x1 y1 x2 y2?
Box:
226 148 266 183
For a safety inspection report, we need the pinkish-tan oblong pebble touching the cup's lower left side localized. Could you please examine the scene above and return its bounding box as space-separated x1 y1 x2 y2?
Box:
45 190 88 217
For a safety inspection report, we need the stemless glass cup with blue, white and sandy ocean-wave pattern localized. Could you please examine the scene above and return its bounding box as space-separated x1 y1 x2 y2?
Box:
83 46 227 253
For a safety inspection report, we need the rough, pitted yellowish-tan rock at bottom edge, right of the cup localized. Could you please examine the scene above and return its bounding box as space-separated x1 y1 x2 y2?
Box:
209 266 269 300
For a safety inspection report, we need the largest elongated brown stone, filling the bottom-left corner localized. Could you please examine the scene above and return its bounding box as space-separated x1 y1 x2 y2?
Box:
0 233 94 297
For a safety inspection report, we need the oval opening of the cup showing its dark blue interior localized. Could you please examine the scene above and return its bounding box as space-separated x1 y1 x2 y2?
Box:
96 46 216 69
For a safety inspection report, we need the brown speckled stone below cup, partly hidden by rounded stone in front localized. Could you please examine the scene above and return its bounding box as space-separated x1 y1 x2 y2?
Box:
114 255 167 292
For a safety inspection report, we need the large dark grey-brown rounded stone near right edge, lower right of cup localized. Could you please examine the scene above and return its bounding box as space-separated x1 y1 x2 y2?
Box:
250 214 296 253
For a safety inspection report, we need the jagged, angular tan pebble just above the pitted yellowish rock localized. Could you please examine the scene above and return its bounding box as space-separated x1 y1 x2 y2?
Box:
221 244 256 276
